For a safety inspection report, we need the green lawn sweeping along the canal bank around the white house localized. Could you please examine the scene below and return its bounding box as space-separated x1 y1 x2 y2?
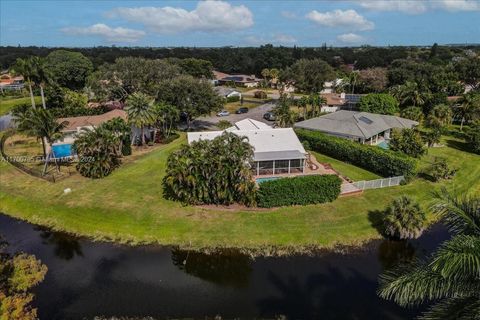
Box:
0 135 480 253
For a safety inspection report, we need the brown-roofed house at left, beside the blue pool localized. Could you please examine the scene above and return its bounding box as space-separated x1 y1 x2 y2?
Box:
55 109 127 144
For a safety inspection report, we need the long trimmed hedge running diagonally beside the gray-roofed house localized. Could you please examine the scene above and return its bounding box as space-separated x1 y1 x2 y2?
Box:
295 129 417 180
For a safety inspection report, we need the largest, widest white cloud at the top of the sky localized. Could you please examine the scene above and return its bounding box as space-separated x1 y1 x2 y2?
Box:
108 0 253 34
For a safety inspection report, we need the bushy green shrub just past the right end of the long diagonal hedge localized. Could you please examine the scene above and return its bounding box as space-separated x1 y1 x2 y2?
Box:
389 129 427 158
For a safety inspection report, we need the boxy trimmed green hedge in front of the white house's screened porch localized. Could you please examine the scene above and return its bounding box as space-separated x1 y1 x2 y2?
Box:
257 175 342 208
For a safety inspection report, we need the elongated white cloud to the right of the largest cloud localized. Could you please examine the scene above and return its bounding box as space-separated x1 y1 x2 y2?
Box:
306 9 375 31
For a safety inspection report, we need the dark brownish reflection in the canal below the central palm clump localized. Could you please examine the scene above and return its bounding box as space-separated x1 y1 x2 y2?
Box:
172 248 252 288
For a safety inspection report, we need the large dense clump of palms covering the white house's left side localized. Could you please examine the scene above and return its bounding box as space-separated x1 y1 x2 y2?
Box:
163 132 256 206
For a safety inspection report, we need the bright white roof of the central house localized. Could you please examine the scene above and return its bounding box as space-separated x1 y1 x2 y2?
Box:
187 119 306 161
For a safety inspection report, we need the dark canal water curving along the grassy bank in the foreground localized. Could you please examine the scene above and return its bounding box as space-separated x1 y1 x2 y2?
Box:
0 214 449 320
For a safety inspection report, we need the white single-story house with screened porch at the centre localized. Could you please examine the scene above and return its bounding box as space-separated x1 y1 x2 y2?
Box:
187 119 307 175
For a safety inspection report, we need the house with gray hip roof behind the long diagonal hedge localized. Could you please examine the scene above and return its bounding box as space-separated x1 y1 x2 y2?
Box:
295 110 418 144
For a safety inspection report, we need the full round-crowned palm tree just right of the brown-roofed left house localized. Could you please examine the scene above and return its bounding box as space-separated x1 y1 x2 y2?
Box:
125 93 154 145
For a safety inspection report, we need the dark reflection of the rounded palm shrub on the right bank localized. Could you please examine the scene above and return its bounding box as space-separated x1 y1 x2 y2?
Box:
378 239 416 269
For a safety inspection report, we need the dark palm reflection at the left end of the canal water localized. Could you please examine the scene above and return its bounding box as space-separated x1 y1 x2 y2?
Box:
35 227 83 261
